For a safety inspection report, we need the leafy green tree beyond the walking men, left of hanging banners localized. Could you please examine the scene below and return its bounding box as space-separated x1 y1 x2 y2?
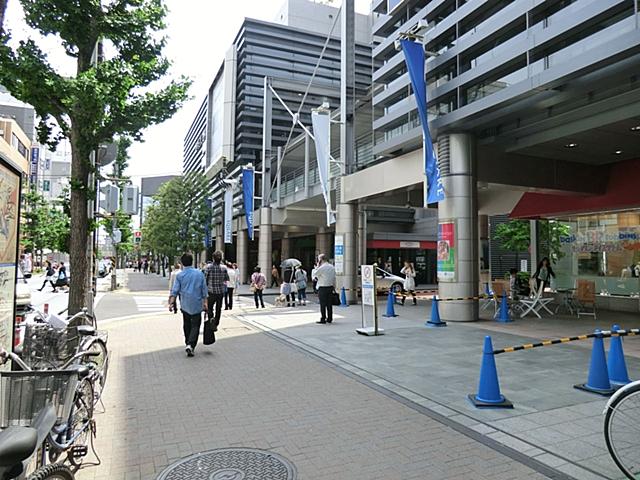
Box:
142 173 210 268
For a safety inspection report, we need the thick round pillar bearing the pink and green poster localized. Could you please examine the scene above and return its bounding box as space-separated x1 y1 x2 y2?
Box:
438 134 479 322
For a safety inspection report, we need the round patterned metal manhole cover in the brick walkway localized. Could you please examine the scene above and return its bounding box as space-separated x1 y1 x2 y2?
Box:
158 448 296 480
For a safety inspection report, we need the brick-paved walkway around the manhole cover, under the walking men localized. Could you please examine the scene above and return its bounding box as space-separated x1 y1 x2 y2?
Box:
77 299 567 480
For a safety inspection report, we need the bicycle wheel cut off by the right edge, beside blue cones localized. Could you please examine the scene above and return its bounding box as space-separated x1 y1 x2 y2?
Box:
604 384 640 480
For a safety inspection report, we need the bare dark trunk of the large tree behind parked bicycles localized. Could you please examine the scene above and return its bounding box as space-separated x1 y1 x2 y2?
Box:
69 127 93 315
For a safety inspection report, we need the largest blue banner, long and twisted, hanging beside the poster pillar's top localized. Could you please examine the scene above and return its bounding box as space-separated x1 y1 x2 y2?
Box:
400 40 445 207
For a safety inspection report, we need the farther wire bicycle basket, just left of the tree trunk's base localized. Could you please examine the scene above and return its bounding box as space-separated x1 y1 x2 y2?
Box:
21 324 80 369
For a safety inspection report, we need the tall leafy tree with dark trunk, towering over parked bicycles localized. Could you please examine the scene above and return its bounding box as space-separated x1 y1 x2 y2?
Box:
0 0 189 314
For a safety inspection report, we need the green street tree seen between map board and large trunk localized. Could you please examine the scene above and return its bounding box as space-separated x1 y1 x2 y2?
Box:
21 190 70 253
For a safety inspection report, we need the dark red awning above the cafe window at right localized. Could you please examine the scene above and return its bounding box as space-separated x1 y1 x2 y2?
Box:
510 160 640 219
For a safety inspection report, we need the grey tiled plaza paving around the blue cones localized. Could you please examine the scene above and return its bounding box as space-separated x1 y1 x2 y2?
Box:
240 301 640 480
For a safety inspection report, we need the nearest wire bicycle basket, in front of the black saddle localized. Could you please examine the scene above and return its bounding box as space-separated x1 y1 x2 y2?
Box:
0 370 78 428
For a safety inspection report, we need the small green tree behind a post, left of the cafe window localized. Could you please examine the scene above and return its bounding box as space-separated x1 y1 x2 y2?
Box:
496 220 569 263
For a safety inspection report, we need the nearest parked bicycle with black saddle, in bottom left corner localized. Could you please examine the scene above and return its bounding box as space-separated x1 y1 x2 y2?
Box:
0 350 78 480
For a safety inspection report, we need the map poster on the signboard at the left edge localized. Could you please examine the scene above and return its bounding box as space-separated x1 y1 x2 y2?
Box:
0 159 20 368
